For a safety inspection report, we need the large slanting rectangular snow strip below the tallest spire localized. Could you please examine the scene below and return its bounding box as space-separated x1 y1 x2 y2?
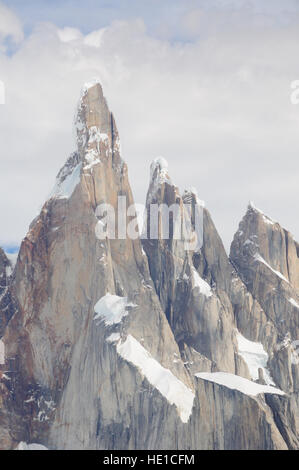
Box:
116 335 195 423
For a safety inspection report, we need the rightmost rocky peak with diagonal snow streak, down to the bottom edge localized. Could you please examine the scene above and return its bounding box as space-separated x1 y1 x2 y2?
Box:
230 203 299 448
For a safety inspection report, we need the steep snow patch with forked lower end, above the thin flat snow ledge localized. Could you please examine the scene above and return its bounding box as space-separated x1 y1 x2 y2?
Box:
236 331 275 385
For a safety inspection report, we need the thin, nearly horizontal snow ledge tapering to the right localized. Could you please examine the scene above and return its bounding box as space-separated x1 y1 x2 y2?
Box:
195 372 285 396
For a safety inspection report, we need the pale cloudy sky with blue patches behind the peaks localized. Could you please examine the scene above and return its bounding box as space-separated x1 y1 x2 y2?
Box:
0 0 299 253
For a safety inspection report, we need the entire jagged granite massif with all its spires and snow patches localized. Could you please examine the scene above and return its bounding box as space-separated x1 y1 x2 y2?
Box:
0 83 299 449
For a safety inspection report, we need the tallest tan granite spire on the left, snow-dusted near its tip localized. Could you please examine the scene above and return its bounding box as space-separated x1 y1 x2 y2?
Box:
3 84 193 448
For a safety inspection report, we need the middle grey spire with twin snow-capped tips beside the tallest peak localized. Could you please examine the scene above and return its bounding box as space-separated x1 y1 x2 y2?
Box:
143 163 239 372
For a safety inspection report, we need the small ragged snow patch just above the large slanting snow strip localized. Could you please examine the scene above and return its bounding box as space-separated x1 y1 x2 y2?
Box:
94 292 137 325
